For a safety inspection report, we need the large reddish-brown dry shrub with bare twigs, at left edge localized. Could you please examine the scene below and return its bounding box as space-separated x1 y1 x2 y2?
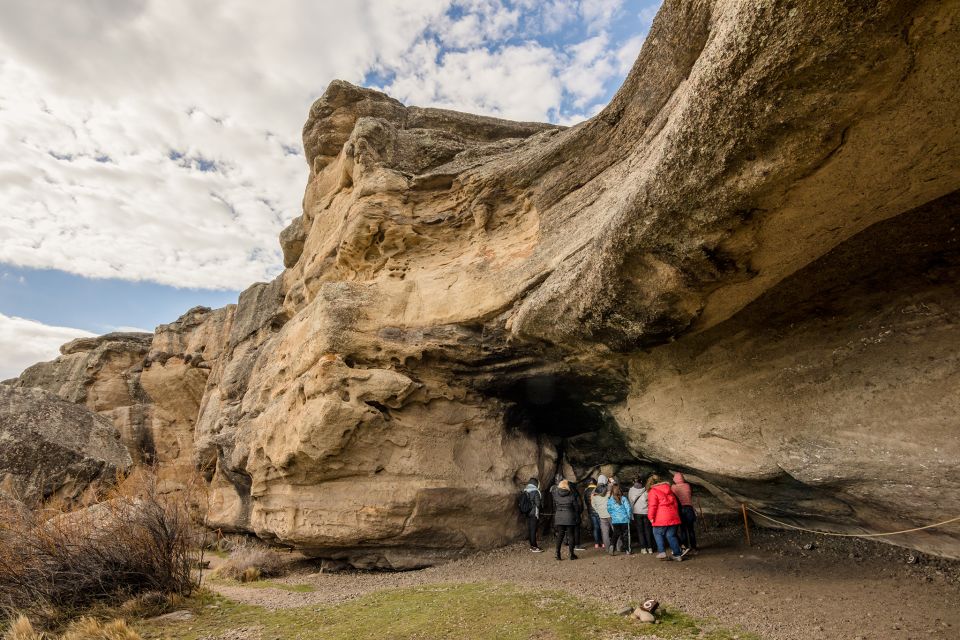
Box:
0 471 196 623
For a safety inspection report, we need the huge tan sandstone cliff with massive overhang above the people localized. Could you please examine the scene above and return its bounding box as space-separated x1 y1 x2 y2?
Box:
7 0 960 568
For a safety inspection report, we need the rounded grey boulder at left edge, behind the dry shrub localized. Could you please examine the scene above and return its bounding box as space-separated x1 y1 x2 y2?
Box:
0 385 132 505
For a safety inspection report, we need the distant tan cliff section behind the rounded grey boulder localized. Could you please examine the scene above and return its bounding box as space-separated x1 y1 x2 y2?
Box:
14 306 234 492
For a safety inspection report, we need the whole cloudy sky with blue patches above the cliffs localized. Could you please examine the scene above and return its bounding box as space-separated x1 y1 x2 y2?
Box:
0 0 660 379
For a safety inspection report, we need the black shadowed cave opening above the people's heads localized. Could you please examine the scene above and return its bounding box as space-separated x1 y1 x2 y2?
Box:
496 375 637 481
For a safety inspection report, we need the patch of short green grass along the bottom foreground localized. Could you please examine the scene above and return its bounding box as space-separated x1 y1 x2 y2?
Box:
131 583 752 640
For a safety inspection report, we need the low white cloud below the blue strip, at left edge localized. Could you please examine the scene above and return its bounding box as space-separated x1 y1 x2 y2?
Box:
0 313 93 380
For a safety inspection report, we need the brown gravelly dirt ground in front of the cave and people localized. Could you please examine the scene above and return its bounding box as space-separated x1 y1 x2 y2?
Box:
204 525 960 640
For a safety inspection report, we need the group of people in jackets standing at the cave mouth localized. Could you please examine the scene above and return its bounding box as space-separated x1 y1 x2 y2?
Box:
518 473 697 561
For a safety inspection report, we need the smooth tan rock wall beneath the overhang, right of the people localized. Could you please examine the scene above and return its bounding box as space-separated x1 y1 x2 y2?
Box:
612 193 960 555
